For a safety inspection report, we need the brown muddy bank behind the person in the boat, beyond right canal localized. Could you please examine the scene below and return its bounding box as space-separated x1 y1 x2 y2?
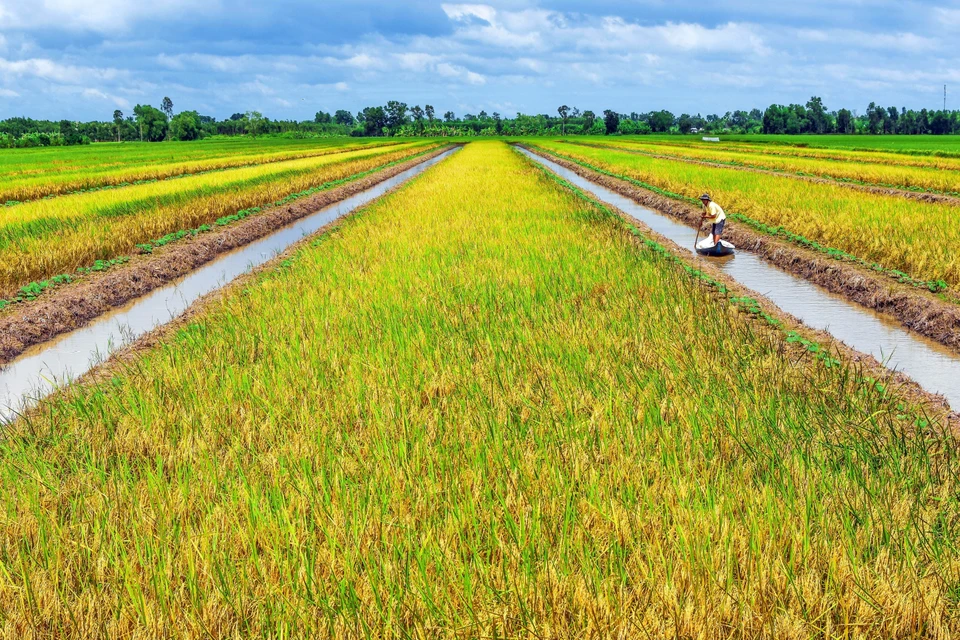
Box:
524 147 960 353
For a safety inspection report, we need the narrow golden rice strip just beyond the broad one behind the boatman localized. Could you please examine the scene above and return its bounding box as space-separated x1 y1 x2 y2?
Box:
585 141 960 198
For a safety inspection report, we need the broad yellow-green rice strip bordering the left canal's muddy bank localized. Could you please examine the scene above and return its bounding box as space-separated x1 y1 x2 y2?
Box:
0 143 438 296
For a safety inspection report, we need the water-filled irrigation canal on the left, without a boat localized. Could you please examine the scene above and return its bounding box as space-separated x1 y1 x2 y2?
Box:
0 147 459 424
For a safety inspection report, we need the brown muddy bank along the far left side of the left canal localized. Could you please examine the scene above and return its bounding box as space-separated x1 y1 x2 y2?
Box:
0 146 450 364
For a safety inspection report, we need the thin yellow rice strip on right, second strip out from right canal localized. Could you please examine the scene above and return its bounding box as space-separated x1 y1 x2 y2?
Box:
589 138 960 194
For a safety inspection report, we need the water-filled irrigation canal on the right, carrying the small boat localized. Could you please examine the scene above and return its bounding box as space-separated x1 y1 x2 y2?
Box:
518 147 960 410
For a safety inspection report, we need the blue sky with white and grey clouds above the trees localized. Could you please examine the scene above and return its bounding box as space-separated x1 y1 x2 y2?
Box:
0 0 960 120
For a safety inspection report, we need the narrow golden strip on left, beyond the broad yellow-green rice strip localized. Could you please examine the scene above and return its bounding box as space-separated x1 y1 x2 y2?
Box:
0 142 408 206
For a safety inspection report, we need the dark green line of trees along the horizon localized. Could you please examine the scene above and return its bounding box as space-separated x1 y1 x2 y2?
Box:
0 96 960 148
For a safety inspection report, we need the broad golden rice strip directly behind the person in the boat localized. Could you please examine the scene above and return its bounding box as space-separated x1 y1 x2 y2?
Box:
531 141 960 288
